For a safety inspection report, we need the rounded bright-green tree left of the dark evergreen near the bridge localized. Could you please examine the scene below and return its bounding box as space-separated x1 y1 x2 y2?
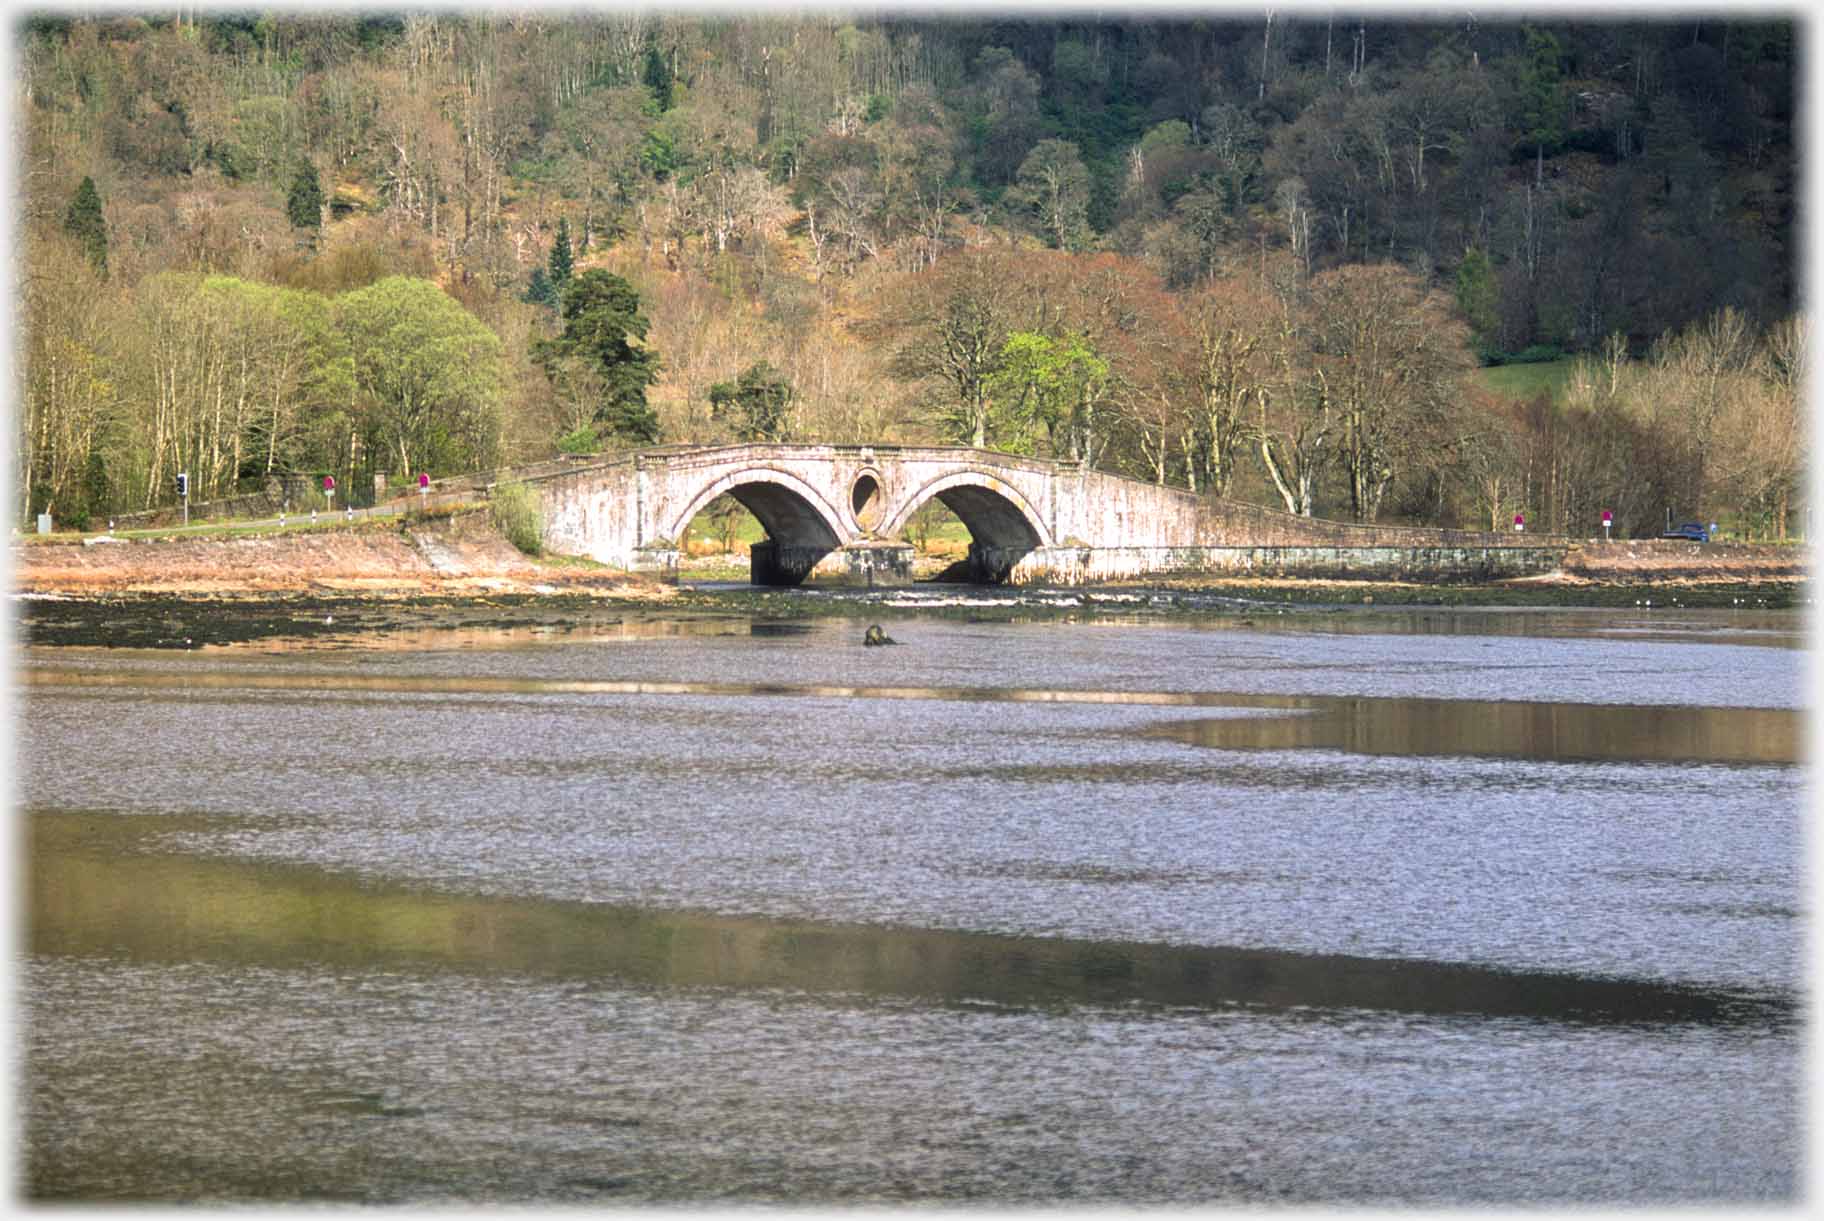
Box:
336 276 505 473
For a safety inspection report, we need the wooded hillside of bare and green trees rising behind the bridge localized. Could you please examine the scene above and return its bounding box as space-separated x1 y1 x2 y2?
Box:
11 5 1808 538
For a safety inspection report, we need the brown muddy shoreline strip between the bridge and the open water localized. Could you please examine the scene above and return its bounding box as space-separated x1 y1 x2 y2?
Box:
11 515 1806 648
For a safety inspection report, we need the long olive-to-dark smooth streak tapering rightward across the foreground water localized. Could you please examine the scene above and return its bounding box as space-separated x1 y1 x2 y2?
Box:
27 812 1791 1024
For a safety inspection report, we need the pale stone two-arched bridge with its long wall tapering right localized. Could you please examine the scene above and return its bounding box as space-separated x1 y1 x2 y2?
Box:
494 445 1569 586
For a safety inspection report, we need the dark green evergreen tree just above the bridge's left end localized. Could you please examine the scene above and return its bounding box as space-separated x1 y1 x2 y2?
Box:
531 268 658 445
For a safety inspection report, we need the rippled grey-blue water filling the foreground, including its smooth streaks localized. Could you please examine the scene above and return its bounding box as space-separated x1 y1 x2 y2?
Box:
15 611 1806 1205
